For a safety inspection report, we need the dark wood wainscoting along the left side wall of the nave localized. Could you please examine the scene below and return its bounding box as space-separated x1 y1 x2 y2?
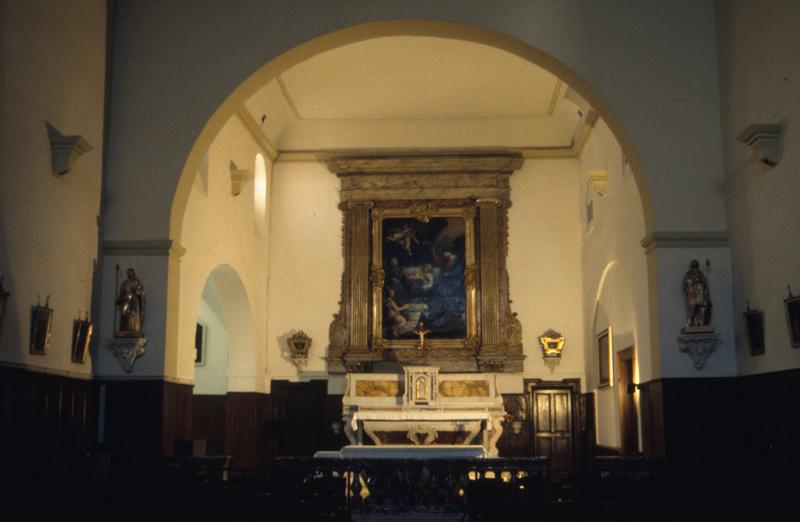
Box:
0 366 97 478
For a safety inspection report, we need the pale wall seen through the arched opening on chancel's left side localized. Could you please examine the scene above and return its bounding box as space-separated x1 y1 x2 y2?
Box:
193 279 229 395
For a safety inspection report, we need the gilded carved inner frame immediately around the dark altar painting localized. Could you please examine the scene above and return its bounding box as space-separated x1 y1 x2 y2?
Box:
371 201 478 351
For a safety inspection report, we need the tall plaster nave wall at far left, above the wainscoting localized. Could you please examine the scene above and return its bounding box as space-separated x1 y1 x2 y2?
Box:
0 0 106 376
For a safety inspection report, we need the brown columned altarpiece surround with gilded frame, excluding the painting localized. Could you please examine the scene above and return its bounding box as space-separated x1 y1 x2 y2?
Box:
324 152 525 373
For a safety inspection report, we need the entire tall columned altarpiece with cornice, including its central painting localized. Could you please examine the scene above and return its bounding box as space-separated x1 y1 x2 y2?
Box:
326 152 524 373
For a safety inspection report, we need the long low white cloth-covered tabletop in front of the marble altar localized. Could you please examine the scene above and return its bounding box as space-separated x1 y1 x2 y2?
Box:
314 444 487 460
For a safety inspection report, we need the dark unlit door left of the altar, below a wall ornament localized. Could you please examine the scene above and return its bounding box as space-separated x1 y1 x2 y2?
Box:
272 381 326 457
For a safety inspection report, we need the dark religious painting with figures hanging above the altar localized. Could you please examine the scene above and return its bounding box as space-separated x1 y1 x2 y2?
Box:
375 205 475 347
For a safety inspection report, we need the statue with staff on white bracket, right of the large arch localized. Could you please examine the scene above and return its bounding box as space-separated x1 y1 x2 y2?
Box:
678 259 722 371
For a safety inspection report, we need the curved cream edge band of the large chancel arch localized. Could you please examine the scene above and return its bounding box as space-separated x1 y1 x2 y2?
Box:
169 20 654 244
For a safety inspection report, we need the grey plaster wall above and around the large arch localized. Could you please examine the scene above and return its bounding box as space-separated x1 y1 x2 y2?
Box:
105 0 726 239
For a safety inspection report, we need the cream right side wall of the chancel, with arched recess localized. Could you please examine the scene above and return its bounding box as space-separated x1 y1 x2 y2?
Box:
578 120 658 447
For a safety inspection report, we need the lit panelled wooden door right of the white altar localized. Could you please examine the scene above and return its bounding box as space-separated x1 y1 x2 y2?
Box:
531 387 574 469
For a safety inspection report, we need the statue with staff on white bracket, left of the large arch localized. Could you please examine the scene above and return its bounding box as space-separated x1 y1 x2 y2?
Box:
109 265 147 373
